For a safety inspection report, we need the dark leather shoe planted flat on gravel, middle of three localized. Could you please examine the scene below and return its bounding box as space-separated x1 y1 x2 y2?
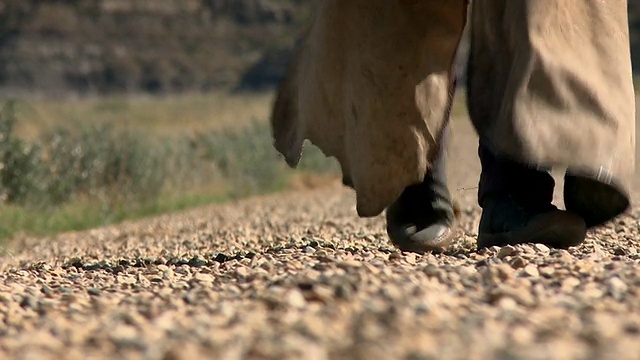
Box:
478 195 587 249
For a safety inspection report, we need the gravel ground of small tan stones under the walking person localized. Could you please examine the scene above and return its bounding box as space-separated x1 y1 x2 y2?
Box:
0 110 640 359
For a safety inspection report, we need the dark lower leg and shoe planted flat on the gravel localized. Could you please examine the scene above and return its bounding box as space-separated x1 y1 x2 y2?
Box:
478 143 586 248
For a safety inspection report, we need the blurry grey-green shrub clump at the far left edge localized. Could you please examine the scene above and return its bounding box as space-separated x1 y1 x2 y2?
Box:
0 103 165 207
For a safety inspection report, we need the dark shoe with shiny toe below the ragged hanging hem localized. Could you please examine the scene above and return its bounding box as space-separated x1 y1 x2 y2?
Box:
386 177 457 253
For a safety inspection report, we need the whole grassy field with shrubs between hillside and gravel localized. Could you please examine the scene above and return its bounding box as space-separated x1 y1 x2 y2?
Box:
0 93 335 242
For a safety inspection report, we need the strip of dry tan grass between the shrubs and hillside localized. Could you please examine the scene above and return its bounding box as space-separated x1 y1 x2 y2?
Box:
9 91 272 139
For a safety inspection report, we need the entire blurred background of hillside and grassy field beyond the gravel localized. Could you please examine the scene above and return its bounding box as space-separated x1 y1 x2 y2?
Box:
0 0 640 240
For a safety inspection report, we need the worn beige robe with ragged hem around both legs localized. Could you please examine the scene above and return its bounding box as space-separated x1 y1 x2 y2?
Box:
271 0 635 217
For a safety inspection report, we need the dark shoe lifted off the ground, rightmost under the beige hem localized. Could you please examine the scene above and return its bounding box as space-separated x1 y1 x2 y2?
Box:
564 174 630 228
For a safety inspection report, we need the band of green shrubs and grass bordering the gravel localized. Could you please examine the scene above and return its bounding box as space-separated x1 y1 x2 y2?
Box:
0 102 338 239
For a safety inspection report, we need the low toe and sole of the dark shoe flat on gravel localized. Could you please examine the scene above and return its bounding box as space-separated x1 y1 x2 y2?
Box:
478 212 587 249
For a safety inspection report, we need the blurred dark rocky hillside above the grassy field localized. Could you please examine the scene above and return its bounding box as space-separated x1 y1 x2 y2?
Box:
0 0 640 94
